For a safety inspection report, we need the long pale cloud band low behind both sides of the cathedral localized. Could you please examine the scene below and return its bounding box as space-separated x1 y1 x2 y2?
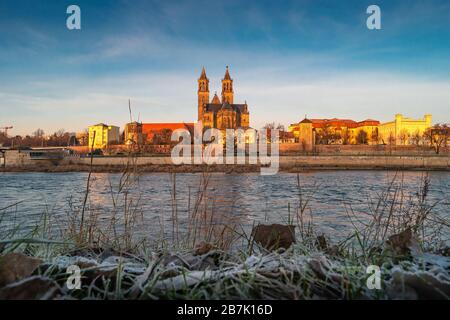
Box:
0 69 450 134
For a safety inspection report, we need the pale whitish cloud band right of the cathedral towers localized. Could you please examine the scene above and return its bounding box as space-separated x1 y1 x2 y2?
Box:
240 72 450 125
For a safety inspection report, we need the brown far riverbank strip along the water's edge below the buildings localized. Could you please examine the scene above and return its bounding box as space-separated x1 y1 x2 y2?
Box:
1 155 450 173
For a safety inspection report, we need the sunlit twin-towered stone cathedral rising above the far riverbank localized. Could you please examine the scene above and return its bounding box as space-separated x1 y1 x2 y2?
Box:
198 67 250 130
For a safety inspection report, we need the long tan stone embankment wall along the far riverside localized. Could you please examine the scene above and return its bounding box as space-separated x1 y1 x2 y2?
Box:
5 146 450 171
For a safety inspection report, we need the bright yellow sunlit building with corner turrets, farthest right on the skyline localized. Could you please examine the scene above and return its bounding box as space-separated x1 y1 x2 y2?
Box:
378 114 432 145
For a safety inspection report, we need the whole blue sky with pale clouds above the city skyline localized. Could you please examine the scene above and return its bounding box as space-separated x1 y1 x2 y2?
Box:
0 0 450 134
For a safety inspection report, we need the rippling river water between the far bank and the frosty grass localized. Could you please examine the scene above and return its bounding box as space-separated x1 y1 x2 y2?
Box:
0 171 450 239
